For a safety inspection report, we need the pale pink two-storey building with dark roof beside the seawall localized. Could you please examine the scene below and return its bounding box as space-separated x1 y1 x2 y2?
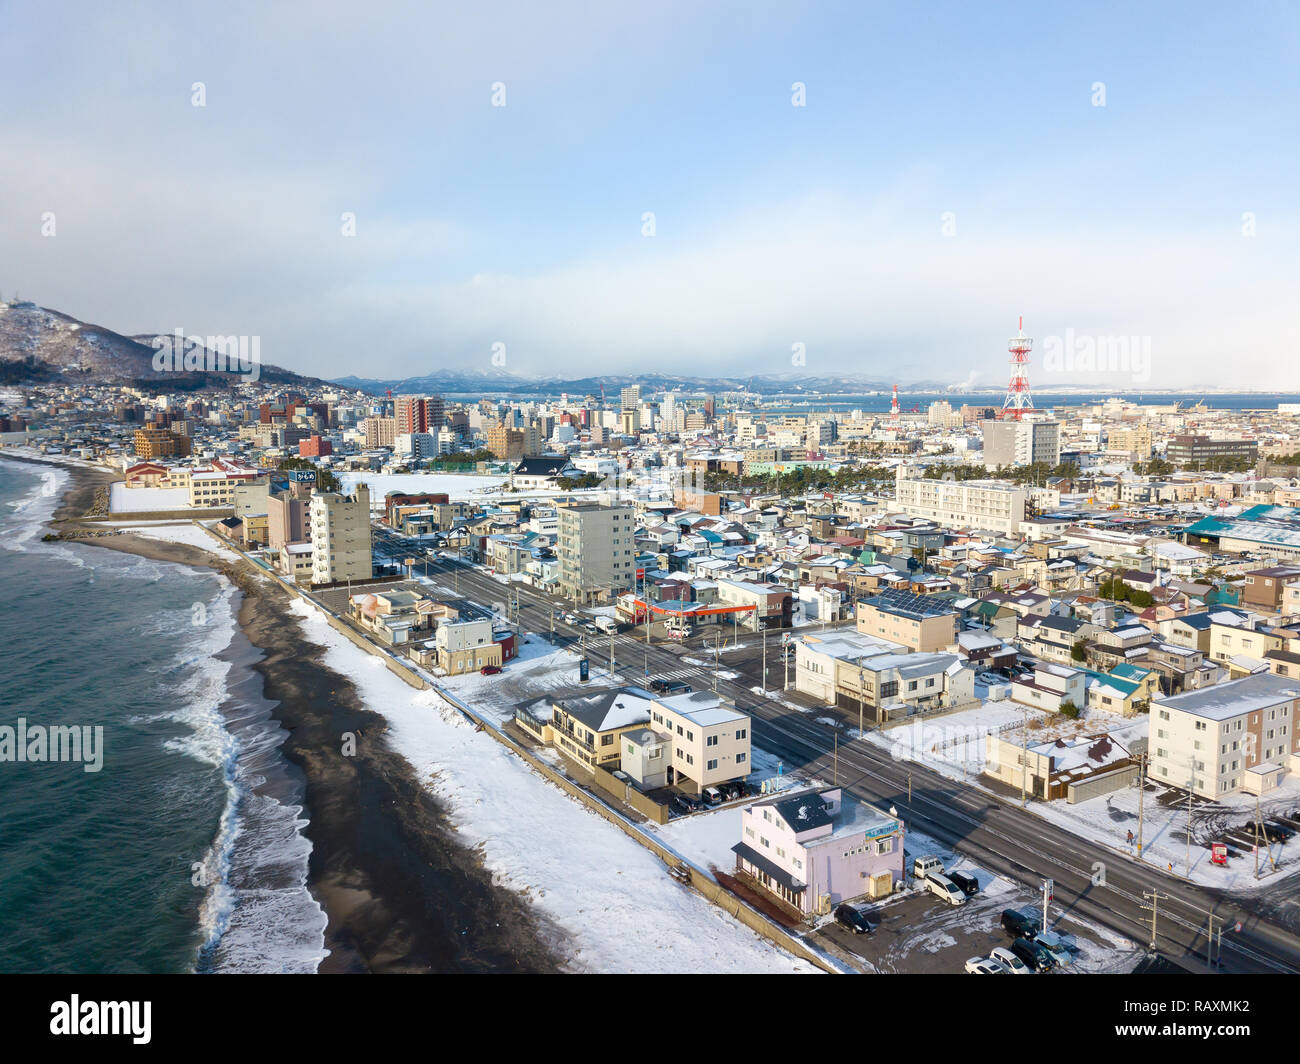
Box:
732 787 904 913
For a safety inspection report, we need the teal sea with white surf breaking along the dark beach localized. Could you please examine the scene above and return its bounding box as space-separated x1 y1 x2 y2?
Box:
0 459 325 973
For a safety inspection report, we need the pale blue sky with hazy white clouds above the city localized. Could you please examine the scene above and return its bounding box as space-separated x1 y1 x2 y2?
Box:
0 0 1300 390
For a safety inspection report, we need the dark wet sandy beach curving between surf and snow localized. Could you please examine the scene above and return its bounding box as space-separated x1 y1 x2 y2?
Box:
20 459 563 972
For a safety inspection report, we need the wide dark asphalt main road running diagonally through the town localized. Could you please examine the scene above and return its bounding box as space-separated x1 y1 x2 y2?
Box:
376 527 1300 972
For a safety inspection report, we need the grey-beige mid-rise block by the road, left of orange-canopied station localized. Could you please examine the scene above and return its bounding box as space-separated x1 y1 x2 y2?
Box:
555 503 636 604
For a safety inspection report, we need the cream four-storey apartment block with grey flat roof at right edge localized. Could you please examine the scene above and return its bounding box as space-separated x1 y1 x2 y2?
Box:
1149 672 1300 799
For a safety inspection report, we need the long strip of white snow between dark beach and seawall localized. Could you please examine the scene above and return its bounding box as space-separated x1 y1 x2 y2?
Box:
293 598 815 972
